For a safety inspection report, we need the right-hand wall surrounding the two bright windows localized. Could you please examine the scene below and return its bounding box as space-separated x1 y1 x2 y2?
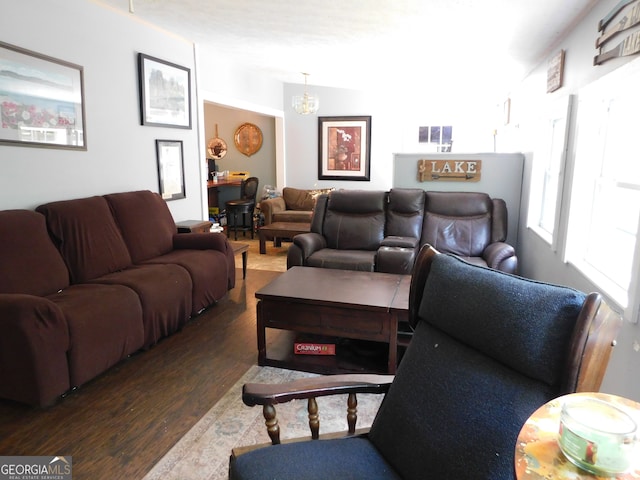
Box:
504 0 640 401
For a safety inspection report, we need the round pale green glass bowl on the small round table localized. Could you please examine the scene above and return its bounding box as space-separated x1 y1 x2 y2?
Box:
558 398 638 476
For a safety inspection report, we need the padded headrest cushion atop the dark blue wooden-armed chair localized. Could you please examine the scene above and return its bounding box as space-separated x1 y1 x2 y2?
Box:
418 255 586 386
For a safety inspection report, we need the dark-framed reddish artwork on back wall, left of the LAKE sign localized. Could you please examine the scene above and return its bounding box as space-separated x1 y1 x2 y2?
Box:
318 116 371 181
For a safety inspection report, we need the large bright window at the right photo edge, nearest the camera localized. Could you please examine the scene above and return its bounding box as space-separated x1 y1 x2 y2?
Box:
566 62 640 308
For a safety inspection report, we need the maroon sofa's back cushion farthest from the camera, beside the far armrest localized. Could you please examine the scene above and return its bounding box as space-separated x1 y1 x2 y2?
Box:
105 190 178 263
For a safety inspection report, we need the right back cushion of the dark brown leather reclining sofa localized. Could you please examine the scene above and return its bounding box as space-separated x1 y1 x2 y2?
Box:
422 192 493 257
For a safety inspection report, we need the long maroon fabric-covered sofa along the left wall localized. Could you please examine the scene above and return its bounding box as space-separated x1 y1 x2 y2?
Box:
0 191 235 406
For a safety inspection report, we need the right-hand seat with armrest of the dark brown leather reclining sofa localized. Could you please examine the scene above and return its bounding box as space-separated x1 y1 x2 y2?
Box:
421 192 518 273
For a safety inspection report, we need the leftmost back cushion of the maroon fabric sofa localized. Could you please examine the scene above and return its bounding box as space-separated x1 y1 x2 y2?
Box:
0 210 69 296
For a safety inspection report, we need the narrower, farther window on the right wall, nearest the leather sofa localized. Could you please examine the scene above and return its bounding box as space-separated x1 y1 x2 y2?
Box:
528 96 572 246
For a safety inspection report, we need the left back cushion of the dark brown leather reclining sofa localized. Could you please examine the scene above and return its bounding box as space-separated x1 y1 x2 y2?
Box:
323 190 386 250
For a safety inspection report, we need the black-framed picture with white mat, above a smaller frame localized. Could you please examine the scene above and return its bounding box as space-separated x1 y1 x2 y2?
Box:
138 53 191 128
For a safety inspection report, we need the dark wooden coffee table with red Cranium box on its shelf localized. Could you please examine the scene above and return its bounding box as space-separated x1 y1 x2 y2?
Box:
255 267 411 373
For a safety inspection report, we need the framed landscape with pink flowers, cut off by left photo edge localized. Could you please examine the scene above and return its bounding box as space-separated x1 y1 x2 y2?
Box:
0 42 87 150
